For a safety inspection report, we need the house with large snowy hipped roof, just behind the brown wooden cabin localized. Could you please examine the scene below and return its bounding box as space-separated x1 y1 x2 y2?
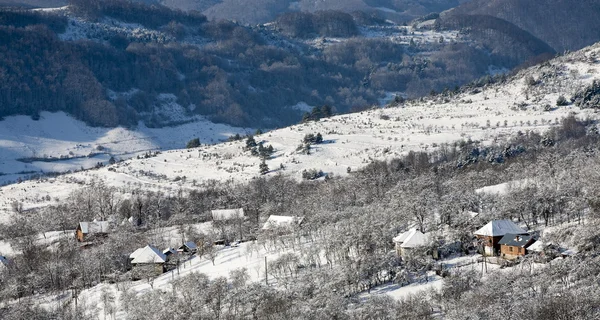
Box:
474 220 528 256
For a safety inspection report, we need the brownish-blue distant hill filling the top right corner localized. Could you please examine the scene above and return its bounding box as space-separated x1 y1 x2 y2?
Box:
445 0 600 52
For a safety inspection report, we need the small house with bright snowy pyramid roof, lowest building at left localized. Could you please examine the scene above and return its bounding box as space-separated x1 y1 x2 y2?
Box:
129 245 167 279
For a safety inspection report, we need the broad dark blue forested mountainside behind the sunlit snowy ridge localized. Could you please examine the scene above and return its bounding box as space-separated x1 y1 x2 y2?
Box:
0 0 543 128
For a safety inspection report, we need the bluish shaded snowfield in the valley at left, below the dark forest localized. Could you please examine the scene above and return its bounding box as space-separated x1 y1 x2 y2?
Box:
0 112 250 184
